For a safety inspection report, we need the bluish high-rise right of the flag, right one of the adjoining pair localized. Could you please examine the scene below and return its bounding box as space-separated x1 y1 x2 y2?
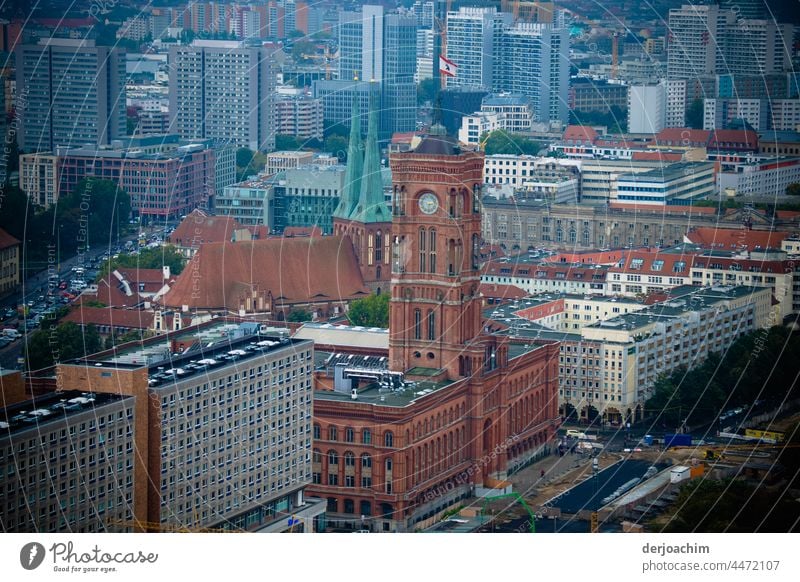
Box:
494 22 569 124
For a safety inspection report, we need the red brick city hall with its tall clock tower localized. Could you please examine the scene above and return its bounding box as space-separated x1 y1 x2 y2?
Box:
309 134 558 531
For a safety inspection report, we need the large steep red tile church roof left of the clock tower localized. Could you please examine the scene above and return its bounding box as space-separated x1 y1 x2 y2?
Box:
163 236 369 310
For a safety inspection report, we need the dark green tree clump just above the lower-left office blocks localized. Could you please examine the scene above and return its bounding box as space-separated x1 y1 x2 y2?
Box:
25 321 100 370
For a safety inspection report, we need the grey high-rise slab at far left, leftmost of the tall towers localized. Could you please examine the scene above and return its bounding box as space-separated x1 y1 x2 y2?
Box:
16 38 125 151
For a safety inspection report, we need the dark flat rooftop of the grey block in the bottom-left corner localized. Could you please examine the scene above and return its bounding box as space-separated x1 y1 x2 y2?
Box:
0 390 132 436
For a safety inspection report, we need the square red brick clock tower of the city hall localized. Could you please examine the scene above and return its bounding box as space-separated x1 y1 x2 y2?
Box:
389 126 490 380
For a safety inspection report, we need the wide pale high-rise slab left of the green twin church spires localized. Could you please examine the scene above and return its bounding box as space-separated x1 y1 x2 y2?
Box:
169 40 275 150
